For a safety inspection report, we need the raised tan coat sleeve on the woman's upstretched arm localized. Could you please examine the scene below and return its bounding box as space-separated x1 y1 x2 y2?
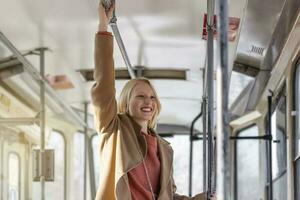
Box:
91 33 117 132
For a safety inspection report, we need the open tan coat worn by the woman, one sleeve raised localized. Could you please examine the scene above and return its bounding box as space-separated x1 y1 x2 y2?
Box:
91 33 204 200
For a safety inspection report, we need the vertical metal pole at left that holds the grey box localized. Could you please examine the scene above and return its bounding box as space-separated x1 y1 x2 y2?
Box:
37 48 46 200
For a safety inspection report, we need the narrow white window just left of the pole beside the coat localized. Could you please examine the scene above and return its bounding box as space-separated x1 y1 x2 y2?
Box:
72 132 85 200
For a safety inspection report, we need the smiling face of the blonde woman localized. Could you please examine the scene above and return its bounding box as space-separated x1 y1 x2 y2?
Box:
128 82 157 125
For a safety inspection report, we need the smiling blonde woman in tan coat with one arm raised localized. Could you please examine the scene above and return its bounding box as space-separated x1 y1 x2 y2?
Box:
91 1 211 200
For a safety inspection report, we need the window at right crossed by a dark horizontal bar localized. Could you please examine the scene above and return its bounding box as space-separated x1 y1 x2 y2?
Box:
236 126 260 200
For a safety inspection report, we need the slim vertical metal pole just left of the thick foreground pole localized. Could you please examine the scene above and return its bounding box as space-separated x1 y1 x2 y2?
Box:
206 0 214 196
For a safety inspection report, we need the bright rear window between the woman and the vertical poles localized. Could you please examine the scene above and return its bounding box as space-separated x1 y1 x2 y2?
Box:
165 135 203 195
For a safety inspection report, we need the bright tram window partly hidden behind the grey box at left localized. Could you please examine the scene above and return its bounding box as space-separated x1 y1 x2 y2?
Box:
32 131 66 200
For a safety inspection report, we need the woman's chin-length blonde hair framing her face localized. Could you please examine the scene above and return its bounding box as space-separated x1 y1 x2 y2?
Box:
118 78 161 129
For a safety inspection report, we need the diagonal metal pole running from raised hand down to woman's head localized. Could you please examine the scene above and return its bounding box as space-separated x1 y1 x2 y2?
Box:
110 11 136 79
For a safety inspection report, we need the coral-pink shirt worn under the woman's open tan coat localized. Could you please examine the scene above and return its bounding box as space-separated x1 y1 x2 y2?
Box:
128 133 160 200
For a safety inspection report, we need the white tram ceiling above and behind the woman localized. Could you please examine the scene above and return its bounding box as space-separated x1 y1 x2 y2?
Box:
0 0 247 128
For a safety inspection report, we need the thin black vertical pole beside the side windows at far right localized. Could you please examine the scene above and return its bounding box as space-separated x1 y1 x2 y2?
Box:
267 91 273 200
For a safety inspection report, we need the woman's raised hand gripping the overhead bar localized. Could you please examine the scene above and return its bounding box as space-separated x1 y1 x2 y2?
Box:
98 0 115 31
